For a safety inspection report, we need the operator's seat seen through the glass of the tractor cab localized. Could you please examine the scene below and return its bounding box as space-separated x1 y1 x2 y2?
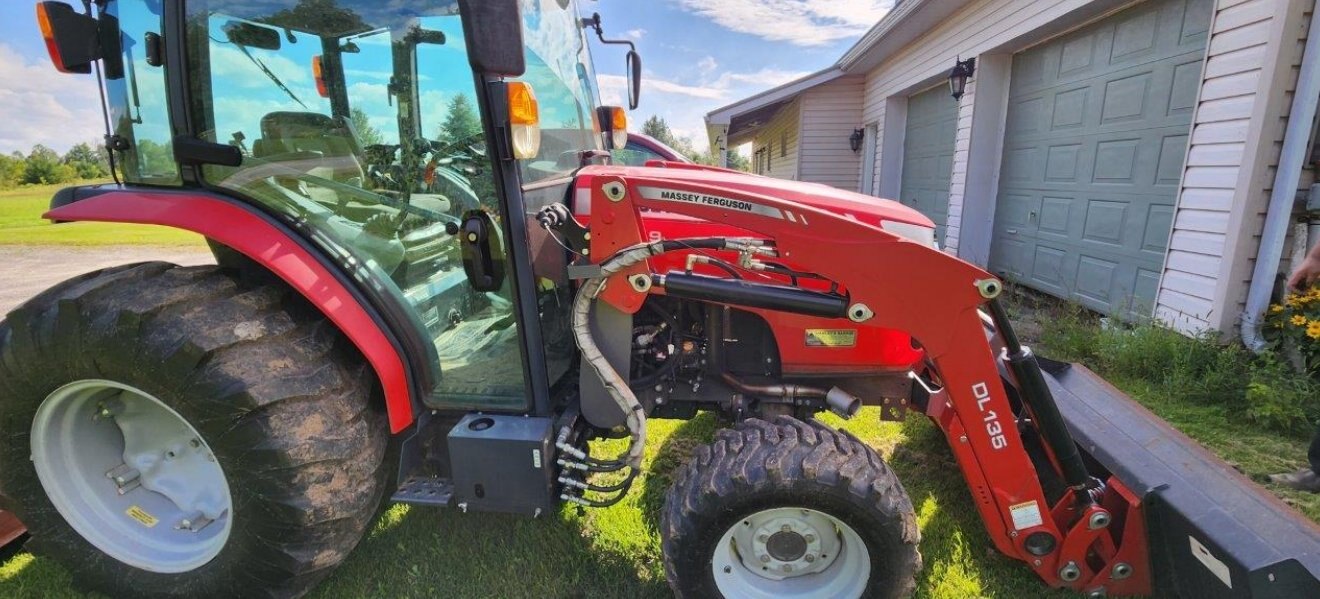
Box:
252 112 364 186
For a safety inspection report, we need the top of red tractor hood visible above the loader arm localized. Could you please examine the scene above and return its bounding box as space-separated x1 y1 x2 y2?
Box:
579 161 935 228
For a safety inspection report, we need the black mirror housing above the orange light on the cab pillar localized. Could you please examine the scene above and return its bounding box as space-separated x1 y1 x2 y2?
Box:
458 0 527 77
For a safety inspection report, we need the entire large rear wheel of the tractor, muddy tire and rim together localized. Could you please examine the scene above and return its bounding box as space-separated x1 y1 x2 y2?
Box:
0 263 388 598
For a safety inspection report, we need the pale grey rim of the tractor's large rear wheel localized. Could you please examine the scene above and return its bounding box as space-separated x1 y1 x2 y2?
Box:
32 380 234 574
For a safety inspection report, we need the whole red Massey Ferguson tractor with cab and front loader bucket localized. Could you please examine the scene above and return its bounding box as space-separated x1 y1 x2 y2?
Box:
0 0 1320 599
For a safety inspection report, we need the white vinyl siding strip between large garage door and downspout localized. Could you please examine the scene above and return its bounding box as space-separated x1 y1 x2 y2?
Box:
1155 0 1312 332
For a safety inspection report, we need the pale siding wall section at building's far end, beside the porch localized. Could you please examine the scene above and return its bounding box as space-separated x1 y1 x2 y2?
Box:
799 77 863 191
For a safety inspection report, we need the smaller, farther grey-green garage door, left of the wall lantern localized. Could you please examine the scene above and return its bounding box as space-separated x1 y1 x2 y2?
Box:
899 86 958 244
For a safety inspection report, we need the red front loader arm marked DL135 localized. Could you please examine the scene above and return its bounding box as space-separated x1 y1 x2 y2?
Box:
578 168 1129 592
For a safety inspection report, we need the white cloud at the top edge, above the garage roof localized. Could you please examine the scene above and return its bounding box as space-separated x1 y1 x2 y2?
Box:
678 0 892 46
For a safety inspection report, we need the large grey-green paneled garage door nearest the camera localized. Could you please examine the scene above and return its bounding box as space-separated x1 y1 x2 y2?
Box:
990 0 1212 317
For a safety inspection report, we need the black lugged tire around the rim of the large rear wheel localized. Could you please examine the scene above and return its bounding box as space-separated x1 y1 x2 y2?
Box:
0 263 388 598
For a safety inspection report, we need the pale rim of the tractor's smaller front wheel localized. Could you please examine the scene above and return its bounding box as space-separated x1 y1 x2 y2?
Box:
710 508 871 599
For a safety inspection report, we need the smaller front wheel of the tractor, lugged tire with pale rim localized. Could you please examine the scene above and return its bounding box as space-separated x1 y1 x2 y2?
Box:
660 416 921 599
